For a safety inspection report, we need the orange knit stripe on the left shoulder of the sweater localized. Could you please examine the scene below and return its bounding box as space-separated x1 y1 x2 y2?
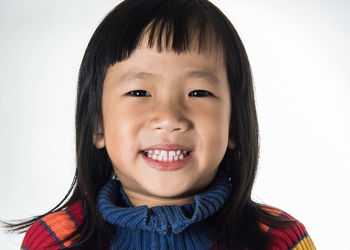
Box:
42 211 76 247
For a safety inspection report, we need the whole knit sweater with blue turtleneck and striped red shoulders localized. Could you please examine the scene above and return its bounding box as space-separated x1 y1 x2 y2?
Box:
22 170 316 250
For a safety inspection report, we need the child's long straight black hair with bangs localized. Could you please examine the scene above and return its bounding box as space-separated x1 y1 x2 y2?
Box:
2 0 293 249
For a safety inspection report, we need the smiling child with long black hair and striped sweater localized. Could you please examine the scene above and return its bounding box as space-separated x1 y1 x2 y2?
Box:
3 0 315 249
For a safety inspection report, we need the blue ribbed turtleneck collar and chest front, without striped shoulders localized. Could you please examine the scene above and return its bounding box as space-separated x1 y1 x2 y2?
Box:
98 170 230 250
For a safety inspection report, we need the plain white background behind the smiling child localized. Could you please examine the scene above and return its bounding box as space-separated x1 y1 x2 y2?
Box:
0 0 350 249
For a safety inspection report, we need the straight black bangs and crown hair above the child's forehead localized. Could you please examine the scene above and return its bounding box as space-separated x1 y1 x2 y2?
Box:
92 0 227 67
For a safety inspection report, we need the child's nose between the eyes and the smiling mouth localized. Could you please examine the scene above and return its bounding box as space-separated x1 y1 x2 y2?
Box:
150 98 191 133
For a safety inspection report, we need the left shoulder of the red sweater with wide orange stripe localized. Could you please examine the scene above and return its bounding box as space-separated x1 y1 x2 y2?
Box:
21 201 83 250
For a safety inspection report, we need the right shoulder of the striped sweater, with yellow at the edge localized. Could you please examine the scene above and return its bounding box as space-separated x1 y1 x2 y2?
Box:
260 205 316 250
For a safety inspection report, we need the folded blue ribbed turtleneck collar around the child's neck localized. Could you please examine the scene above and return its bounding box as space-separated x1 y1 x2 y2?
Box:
97 170 230 234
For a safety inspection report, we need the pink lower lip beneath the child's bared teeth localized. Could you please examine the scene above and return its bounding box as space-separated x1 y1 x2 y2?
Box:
140 147 193 171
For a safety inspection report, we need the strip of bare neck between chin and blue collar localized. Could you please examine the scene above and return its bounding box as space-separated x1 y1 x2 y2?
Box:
124 187 194 208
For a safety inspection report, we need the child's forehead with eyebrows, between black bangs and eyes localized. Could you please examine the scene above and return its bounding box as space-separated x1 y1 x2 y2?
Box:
105 34 227 90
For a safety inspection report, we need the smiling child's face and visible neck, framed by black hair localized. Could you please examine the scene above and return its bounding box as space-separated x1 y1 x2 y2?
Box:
95 38 231 206
